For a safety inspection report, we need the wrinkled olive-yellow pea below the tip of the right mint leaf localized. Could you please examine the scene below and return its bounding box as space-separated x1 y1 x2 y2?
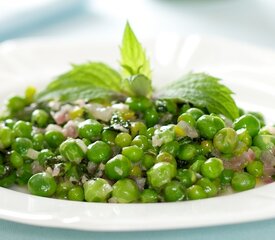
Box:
213 128 238 153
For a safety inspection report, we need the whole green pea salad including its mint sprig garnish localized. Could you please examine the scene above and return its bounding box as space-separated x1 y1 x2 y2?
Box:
0 23 275 203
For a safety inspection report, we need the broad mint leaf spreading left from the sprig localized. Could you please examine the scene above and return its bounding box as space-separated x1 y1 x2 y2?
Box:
37 62 123 101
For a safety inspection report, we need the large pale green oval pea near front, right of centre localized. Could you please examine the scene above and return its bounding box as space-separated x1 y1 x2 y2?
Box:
147 162 177 189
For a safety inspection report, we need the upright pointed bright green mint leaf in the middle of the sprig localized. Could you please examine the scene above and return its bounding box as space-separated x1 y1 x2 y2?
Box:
120 22 151 80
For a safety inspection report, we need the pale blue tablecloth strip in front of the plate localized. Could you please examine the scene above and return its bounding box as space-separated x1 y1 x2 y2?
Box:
0 220 275 240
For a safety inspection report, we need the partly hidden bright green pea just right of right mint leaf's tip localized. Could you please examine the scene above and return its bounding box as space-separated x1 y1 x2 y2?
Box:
233 114 261 137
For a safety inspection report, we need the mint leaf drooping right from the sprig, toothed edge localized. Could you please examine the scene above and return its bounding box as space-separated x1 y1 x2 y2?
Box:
157 73 239 120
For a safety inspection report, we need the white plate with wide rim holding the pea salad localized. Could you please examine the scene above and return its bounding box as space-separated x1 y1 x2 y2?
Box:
0 35 275 231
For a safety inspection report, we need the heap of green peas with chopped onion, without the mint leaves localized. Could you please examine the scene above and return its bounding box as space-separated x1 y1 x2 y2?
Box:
0 88 275 203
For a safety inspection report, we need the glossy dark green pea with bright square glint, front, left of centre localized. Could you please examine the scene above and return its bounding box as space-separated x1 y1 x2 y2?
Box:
105 154 132 180
